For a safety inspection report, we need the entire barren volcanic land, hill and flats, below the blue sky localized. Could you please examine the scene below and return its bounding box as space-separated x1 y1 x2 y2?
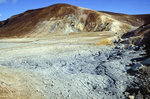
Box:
0 4 150 99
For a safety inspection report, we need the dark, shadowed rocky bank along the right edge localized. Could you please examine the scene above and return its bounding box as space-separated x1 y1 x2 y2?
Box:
122 19 150 99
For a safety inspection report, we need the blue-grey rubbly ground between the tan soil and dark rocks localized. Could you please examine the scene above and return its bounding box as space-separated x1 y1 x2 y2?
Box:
0 36 144 99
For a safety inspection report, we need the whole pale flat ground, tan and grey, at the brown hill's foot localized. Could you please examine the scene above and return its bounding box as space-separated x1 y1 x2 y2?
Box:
0 33 142 99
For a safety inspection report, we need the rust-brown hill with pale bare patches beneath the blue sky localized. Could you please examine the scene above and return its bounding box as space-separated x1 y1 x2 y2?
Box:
0 4 139 37
